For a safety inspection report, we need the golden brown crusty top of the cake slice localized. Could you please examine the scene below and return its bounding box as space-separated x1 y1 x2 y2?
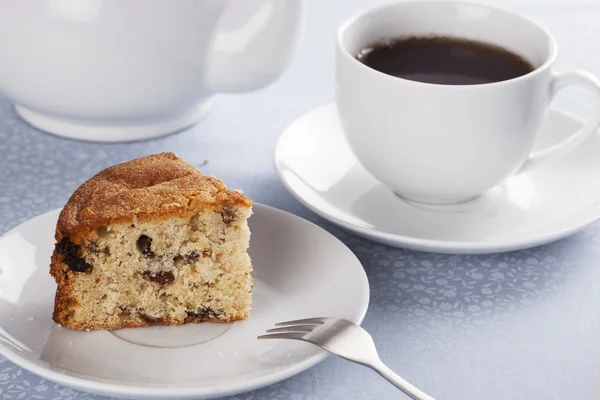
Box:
56 153 252 243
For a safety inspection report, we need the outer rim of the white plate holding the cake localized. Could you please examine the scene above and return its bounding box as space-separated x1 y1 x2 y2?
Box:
0 202 371 399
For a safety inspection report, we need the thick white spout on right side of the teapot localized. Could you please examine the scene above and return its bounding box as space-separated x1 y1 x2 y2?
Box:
205 0 302 92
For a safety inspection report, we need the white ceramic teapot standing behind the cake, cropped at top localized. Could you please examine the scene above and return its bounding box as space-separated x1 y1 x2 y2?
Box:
0 0 301 141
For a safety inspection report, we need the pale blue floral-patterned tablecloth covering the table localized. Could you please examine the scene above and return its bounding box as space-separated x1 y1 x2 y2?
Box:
0 0 600 400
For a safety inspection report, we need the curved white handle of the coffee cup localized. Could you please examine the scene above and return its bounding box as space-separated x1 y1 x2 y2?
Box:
519 71 600 173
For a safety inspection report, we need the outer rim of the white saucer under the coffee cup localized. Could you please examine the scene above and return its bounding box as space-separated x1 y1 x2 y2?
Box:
273 102 600 255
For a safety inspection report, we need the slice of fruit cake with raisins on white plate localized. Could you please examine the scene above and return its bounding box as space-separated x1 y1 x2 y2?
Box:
50 153 252 329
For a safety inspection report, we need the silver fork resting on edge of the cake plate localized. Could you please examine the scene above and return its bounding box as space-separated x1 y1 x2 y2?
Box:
258 318 434 400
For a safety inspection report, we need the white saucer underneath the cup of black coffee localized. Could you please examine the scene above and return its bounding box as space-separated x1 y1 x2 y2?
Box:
275 105 600 254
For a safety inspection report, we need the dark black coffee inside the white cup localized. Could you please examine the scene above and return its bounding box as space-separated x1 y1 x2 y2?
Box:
356 37 534 85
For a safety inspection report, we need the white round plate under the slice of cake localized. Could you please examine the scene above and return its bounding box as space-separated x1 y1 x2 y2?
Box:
0 204 369 399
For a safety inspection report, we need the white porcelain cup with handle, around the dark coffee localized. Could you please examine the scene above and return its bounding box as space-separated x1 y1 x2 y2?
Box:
336 0 600 203
